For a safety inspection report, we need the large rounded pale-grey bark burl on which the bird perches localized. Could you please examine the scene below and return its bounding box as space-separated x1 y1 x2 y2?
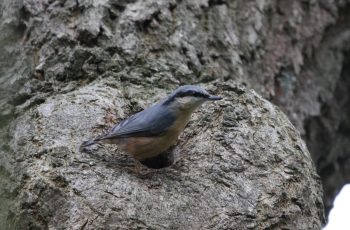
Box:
6 82 323 229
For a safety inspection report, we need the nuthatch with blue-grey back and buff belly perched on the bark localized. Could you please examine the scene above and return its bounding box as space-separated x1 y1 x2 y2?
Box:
80 85 222 168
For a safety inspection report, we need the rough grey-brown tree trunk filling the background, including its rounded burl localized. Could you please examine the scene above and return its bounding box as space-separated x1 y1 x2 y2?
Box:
0 0 350 228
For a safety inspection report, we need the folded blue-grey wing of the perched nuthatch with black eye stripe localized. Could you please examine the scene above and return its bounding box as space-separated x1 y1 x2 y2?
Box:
102 104 175 139
